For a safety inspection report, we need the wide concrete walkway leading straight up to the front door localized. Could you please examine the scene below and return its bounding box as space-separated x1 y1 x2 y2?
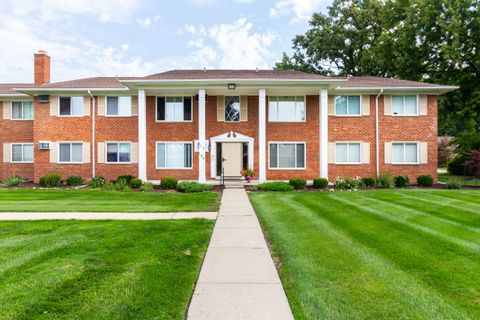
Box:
188 189 293 320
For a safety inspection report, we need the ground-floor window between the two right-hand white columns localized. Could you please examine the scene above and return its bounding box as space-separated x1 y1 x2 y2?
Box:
270 142 305 169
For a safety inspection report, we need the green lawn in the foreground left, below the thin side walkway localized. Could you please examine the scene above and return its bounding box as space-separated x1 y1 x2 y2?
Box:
0 219 213 320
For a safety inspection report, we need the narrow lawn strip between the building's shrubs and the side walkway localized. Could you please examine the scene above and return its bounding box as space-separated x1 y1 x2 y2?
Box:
0 189 220 212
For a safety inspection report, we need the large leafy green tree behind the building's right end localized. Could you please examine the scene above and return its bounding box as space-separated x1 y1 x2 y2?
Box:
276 0 480 142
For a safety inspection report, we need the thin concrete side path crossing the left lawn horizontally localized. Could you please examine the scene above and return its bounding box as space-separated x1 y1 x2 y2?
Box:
0 212 217 221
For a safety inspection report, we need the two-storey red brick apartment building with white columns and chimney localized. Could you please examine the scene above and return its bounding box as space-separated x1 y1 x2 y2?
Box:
0 51 456 181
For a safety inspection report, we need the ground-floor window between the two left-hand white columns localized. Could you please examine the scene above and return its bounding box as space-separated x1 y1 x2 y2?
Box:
157 142 192 169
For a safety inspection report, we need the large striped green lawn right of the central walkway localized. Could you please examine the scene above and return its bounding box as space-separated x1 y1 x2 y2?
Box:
250 189 480 319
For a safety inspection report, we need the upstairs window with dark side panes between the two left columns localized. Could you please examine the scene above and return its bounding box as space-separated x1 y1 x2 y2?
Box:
157 97 192 122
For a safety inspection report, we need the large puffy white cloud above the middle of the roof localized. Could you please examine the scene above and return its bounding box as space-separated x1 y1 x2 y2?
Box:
185 18 276 69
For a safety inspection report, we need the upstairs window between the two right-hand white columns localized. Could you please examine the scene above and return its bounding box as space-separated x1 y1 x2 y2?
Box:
268 96 306 122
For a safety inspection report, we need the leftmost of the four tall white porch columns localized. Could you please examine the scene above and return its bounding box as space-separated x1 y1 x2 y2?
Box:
138 90 147 181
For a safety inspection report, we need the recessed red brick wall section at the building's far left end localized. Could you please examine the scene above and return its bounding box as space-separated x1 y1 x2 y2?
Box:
0 101 33 181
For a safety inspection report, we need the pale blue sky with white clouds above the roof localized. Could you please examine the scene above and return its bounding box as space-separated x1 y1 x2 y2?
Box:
0 0 331 83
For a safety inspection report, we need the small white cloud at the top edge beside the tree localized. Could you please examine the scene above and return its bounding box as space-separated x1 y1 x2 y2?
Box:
268 0 330 23
